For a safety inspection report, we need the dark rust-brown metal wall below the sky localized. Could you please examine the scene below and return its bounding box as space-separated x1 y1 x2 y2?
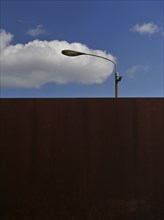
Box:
0 98 164 220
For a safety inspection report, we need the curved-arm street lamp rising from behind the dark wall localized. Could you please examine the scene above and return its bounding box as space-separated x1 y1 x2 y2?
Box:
61 50 122 98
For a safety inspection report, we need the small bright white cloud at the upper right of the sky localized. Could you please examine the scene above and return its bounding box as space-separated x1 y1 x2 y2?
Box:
131 22 160 35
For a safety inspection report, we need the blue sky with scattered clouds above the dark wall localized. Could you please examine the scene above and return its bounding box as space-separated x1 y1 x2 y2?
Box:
0 0 164 98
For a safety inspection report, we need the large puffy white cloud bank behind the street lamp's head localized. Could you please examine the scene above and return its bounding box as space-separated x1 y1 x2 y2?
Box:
0 30 115 88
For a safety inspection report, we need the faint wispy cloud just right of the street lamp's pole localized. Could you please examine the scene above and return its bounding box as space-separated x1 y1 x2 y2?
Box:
126 65 150 79
